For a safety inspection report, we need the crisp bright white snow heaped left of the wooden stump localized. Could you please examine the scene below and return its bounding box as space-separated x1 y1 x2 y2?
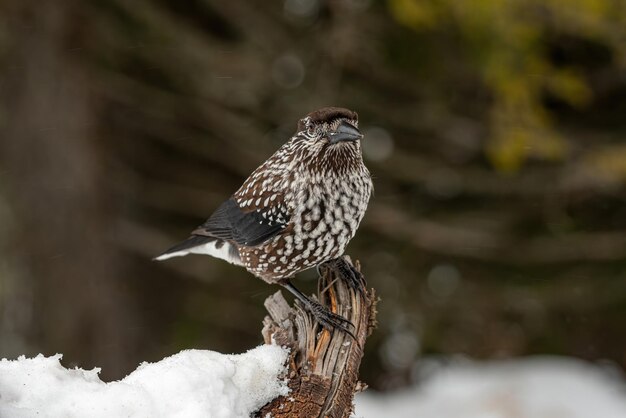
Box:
0 345 288 418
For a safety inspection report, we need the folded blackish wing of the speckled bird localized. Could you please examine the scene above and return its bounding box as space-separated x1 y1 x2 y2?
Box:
192 197 289 247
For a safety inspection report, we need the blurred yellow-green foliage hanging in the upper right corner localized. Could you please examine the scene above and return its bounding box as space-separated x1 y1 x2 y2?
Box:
389 0 626 173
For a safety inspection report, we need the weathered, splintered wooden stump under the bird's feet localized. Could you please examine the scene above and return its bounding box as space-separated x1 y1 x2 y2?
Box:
257 256 377 418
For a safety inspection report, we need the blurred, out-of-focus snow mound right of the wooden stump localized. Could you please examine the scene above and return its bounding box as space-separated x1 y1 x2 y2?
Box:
354 357 626 418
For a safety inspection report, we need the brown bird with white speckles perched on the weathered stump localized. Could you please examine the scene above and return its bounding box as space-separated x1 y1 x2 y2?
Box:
155 107 373 336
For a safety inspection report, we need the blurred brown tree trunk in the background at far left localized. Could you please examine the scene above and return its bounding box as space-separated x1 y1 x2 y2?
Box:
0 0 139 377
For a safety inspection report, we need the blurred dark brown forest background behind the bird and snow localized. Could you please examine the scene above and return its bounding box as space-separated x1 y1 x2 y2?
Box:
0 0 626 390
